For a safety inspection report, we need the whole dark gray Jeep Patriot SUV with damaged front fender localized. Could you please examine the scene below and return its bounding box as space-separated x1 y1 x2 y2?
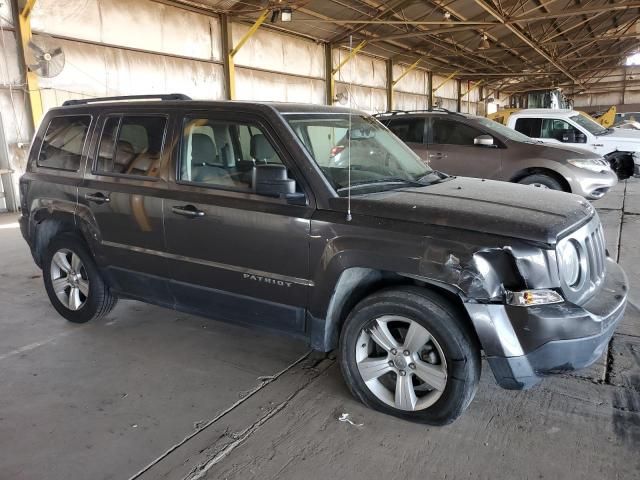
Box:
20 95 627 424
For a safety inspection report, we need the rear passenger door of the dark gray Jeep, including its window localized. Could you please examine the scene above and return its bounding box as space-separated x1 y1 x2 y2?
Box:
78 110 173 305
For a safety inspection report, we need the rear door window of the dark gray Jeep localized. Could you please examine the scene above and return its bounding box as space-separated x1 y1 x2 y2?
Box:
94 115 167 178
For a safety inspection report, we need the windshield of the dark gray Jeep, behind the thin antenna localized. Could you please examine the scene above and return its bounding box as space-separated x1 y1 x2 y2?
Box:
285 113 445 195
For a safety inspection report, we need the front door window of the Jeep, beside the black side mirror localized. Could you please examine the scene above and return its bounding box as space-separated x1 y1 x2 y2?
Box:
178 118 288 191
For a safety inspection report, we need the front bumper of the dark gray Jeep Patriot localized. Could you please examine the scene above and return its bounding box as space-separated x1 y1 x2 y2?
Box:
465 259 628 390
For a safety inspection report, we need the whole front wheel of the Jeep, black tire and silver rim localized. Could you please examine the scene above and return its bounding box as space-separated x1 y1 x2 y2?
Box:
339 287 480 425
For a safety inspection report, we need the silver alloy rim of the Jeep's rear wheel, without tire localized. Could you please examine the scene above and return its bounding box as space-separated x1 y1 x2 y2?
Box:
50 249 89 311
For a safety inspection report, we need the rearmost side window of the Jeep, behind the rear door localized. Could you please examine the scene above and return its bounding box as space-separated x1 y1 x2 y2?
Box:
37 115 91 172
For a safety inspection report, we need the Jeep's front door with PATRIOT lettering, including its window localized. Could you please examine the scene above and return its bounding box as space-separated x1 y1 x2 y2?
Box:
164 113 313 334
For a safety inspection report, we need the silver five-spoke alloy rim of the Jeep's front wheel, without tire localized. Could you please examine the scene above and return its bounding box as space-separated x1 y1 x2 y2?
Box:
356 315 447 411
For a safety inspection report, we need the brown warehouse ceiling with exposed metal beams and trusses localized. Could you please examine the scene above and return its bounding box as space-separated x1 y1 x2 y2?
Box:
164 0 640 93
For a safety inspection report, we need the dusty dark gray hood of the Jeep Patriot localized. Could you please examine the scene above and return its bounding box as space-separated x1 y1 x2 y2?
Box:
351 177 595 245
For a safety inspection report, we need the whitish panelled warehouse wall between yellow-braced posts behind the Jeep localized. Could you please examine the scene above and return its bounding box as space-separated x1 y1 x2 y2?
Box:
0 0 477 210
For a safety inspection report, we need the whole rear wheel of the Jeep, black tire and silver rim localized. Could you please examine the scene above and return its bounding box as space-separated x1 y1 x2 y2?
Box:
42 233 117 323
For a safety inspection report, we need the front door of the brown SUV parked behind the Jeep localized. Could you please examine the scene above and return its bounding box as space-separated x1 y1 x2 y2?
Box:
427 115 503 178
